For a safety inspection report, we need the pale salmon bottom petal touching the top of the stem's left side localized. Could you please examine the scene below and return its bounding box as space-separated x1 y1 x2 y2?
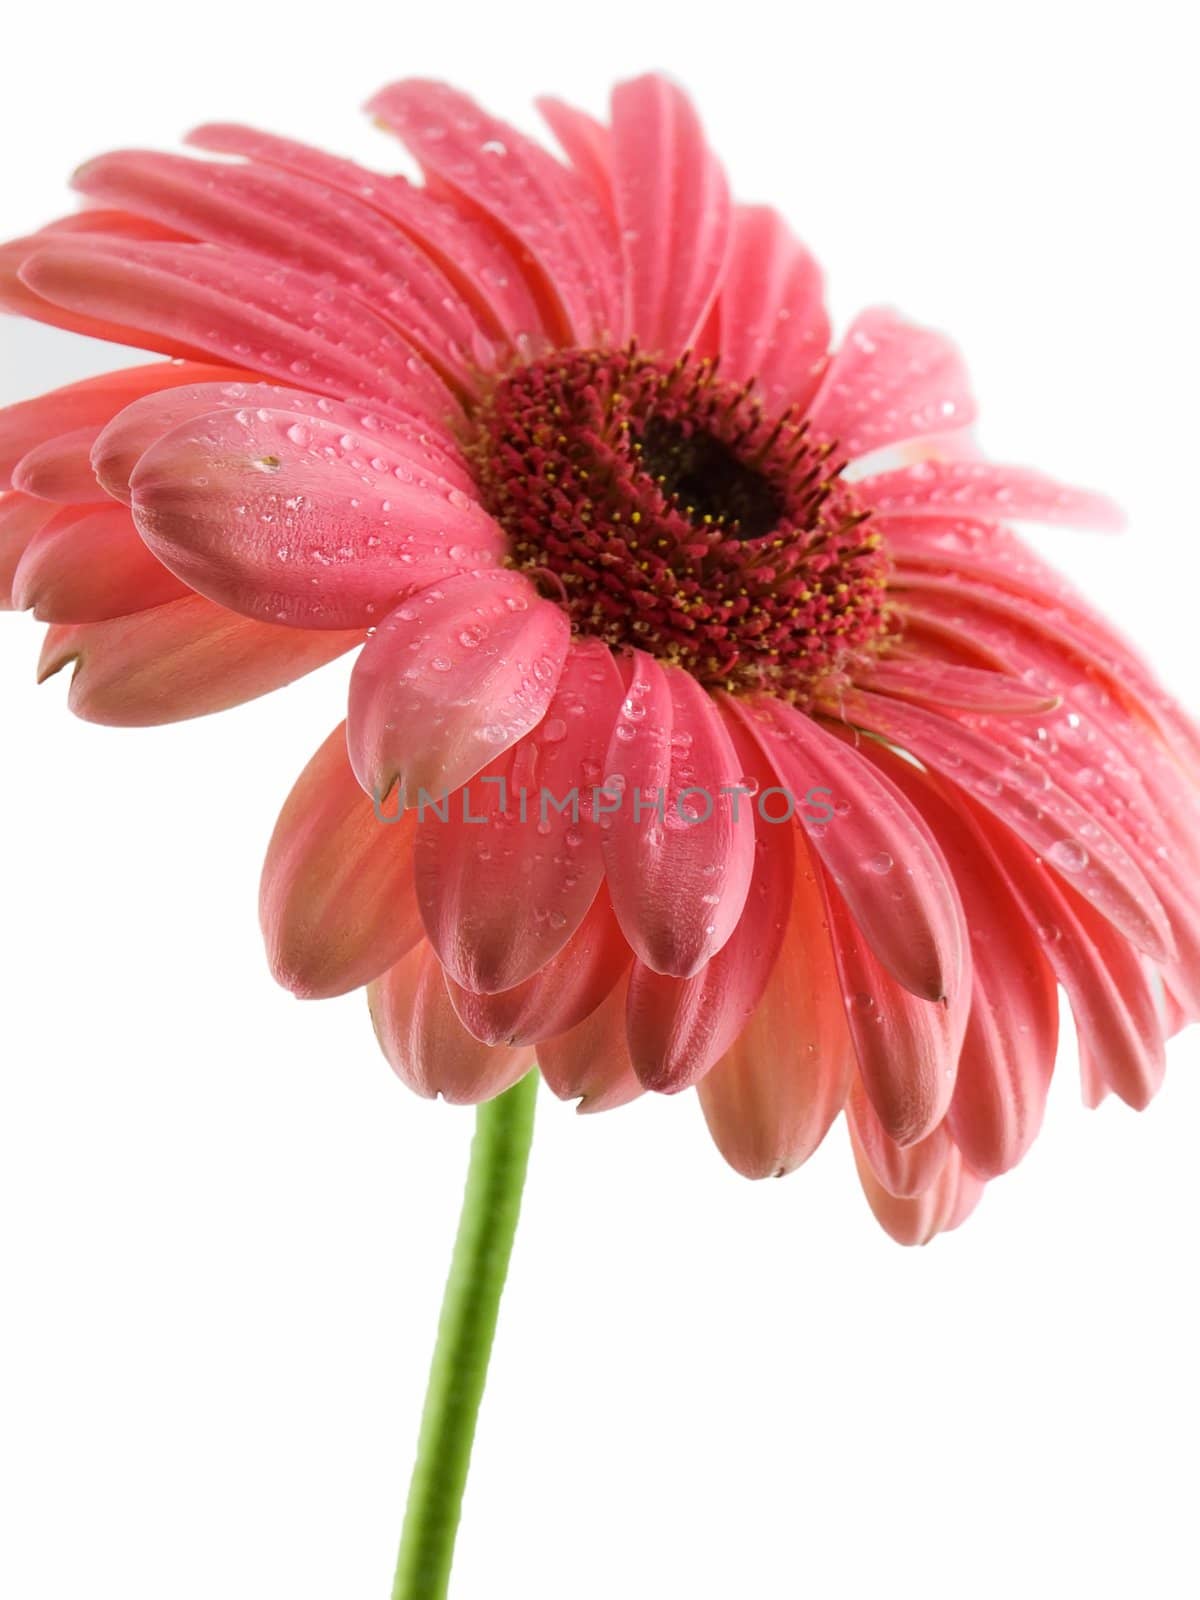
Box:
366 942 533 1106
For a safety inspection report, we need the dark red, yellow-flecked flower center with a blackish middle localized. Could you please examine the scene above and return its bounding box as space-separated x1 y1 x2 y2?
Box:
472 346 888 699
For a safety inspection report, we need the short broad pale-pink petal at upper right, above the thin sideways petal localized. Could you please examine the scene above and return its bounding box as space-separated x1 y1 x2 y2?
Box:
810 307 974 464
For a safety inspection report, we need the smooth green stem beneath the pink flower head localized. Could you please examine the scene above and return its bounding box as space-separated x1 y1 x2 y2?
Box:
392 1070 538 1600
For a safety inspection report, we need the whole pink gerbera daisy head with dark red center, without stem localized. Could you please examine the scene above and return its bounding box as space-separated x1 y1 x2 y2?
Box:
0 77 1200 1243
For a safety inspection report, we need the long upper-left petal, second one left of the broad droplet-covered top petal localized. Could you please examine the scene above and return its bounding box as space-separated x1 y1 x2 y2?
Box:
72 150 494 392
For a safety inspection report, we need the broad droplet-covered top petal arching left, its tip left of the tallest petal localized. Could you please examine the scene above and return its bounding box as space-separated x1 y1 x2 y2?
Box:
366 78 621 346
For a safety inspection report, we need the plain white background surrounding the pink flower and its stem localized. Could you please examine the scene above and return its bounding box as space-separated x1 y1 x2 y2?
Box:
0 0 1200 1600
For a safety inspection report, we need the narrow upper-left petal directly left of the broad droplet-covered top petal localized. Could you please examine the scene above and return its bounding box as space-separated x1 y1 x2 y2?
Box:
187 123 546 355
